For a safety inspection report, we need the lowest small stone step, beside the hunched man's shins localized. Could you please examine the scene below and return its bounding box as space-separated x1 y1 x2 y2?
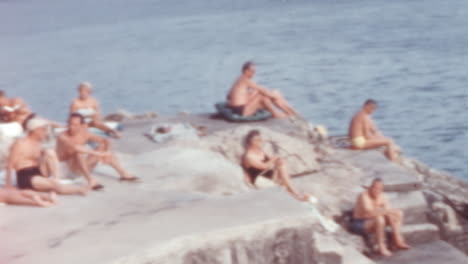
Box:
401 224 440 245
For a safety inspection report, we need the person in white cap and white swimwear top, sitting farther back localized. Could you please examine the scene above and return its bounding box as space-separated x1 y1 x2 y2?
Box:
70 82 120 138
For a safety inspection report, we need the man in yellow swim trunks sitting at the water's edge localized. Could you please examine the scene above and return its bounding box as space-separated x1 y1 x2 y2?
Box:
349 99 397 161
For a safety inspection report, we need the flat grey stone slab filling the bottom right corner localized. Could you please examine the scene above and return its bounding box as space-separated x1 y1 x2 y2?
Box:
376 240 468 264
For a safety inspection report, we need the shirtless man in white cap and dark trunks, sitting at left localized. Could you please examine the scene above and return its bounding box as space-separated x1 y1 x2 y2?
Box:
6 118 88 195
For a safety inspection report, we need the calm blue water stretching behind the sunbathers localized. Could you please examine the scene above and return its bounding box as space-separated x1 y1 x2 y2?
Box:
0 0 468 179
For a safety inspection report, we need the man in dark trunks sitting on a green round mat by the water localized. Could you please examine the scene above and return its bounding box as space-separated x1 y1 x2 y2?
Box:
228 61 297 118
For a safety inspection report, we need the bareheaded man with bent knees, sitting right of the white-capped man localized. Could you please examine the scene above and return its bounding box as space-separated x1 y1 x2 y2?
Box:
56 113 138 190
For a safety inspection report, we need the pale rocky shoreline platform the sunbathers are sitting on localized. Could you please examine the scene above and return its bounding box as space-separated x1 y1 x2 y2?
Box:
0 113 468 264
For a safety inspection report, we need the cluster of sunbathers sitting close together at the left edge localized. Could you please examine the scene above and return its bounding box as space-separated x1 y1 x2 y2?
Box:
0 83 138 206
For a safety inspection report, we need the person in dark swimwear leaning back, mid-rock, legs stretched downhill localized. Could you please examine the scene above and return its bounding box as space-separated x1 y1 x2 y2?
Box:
242 130 309 201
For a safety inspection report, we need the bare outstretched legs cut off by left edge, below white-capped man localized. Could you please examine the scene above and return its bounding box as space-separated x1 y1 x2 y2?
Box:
0 187 58 207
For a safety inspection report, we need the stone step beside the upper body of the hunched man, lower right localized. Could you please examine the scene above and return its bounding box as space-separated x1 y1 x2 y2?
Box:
386 191 429 225
